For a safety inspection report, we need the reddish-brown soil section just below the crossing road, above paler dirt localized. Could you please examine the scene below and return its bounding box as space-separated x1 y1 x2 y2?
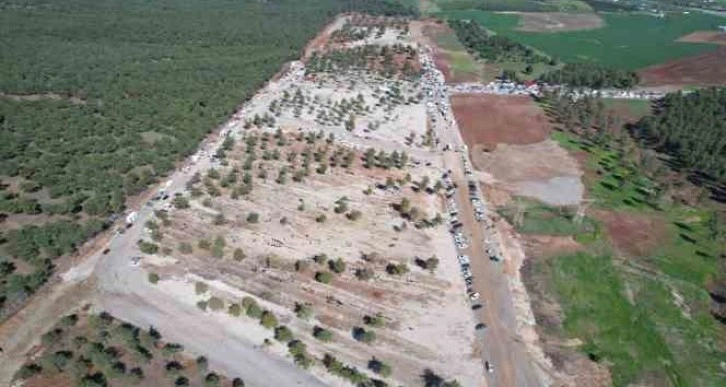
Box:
451 94 553 148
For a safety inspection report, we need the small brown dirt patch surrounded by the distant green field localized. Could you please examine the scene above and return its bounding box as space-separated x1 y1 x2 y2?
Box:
517 12 605 32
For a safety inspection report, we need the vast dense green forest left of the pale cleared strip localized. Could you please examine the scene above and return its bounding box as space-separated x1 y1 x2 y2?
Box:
0 0 414 319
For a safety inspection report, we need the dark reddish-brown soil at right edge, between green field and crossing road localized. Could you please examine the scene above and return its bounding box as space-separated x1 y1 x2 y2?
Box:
639 47 726 86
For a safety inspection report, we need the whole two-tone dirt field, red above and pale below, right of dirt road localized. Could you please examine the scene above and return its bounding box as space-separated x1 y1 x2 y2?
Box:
458 94 583 205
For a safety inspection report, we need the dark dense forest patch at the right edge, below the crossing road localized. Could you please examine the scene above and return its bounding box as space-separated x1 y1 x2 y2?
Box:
635 88 726 185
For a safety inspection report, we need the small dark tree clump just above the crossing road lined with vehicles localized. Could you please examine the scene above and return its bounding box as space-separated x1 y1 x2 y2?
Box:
540 62 639 89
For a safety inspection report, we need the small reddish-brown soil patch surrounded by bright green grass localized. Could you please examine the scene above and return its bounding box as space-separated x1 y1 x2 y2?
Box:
593 211 667 257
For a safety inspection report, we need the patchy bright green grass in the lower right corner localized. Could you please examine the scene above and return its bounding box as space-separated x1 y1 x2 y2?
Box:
544 132 726 386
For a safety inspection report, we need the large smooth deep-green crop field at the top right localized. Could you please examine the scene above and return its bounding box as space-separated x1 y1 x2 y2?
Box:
438 10 724 70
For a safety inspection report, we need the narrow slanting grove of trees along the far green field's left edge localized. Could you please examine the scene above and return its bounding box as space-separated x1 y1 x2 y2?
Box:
449 20 549 64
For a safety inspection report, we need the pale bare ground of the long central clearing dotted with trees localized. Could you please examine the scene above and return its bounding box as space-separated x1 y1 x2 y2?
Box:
126 19 482 385
